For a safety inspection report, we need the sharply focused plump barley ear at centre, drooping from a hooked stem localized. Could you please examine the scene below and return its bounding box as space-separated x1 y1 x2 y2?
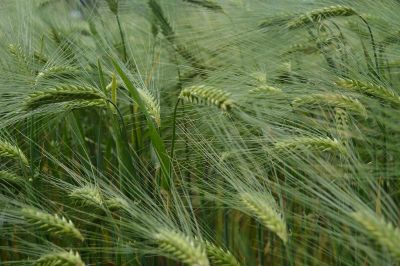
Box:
179 85 235 111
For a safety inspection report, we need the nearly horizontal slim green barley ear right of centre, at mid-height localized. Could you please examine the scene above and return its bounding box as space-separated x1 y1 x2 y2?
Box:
273 137 346 155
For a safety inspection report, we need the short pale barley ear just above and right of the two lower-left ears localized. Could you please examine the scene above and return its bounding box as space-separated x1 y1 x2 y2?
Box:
69 186 103 208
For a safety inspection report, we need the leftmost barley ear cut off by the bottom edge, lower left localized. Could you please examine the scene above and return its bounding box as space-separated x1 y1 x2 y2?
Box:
34 250 85 266
